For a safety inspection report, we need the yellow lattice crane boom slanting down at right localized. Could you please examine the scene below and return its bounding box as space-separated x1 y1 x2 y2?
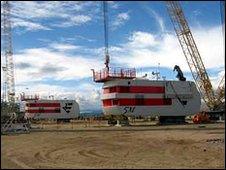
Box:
166 1 218 110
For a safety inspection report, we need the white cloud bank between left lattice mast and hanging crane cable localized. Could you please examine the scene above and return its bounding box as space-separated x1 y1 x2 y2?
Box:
14 48 102 84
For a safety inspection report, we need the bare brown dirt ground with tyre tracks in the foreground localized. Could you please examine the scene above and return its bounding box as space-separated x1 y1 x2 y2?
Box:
1 122 225 169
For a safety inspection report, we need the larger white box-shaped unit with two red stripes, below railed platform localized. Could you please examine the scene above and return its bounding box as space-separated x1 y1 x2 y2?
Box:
102 78 201 116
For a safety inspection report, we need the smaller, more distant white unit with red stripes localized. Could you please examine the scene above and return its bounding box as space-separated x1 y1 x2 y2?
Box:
25 99 80 119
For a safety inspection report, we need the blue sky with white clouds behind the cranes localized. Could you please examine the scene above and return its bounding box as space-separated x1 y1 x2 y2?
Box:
1 1 225 110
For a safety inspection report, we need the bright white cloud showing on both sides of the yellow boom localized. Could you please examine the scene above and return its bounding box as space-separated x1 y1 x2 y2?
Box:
112 26 224 72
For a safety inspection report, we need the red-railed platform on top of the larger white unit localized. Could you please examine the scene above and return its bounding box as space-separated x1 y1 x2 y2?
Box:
92 67 136 83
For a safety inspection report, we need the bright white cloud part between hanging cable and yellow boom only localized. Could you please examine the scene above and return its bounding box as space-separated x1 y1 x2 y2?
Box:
113 31 189 70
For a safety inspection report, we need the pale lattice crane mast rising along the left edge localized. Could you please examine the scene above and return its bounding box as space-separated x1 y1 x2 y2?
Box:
1 1 15 103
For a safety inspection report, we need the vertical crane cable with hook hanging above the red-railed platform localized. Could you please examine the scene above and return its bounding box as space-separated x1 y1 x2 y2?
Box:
103 1 110 70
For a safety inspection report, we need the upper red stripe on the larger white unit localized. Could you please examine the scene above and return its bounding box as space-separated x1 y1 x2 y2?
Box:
103 86 165 94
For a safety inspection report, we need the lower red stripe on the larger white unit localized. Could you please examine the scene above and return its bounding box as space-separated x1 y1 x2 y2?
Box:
102 98 172 107
